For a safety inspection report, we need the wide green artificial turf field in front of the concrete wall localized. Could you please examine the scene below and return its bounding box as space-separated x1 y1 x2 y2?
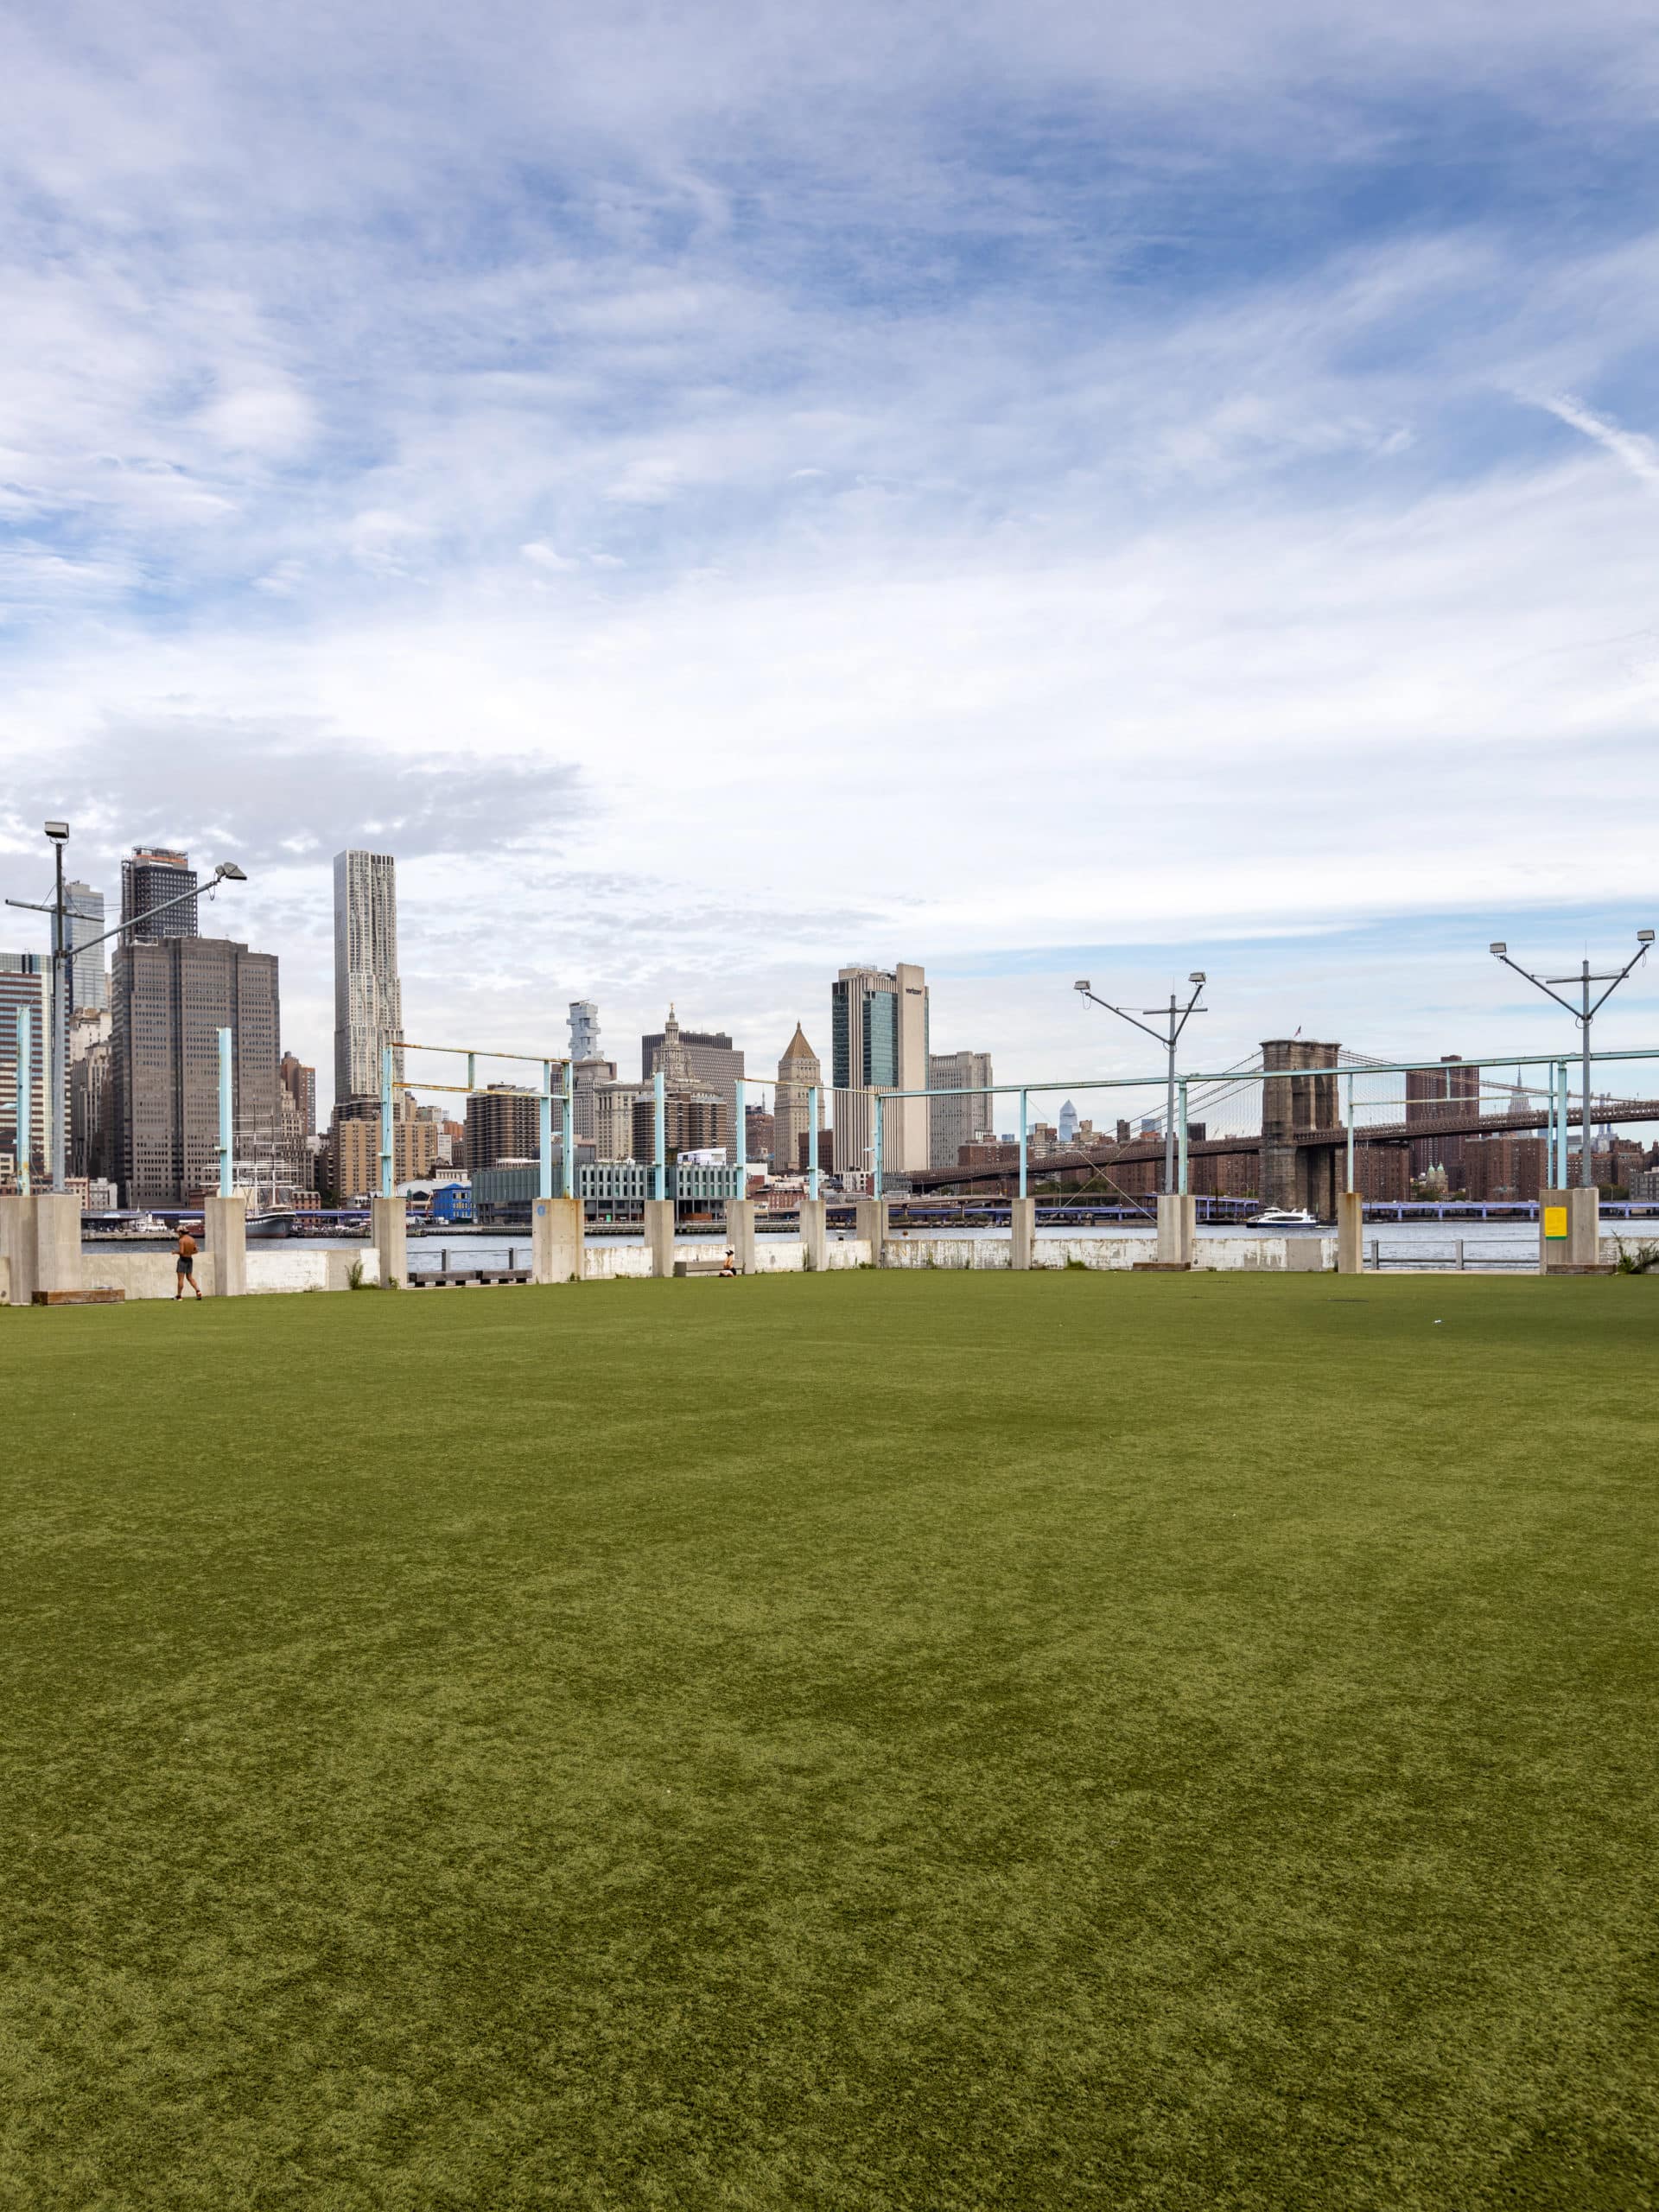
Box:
0 1272 1659 2212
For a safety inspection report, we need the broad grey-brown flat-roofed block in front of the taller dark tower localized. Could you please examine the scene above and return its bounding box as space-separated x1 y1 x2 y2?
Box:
111 936 281 1205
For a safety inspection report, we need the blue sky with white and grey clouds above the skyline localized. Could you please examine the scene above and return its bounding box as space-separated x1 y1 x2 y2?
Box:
0 0 1659 1093
